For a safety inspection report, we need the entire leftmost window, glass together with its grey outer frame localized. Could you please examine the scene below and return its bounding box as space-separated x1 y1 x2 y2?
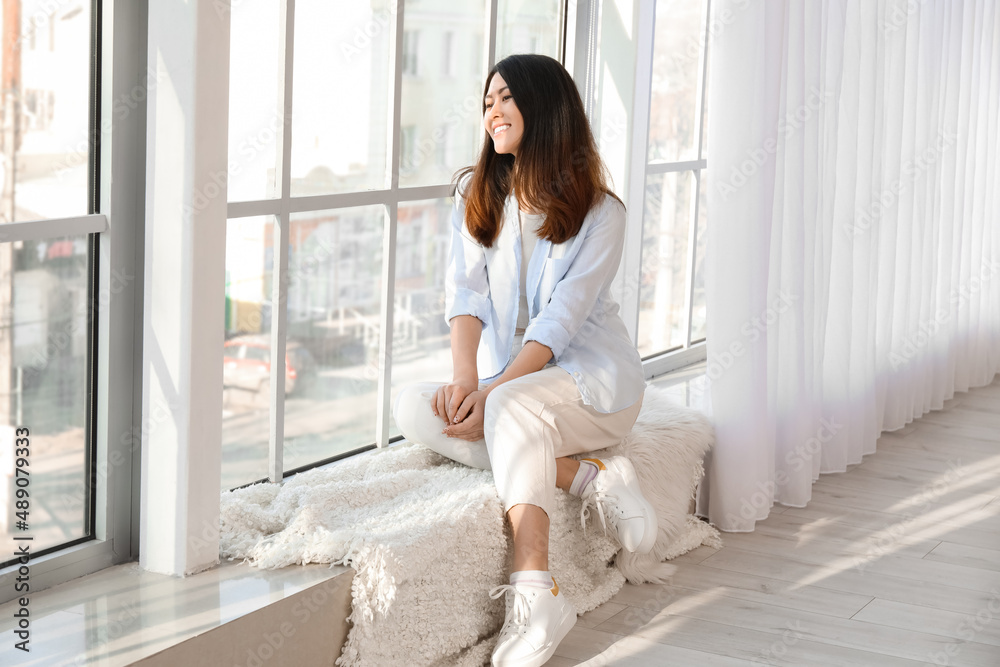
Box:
0 0 139 602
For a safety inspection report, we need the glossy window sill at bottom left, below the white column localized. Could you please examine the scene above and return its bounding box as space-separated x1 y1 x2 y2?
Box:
0 562 353 667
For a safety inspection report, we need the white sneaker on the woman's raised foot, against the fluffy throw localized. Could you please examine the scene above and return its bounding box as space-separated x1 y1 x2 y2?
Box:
580 456 658 554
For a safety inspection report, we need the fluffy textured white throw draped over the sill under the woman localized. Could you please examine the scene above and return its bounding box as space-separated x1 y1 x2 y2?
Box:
222 386 721 667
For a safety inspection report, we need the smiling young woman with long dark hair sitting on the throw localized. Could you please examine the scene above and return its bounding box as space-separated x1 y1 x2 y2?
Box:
393 55 656 667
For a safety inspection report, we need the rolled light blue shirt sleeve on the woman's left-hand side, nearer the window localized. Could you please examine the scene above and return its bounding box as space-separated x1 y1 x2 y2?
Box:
445 189 491 326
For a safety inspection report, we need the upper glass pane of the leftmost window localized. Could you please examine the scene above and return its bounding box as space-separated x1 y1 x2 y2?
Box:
0 2 92 222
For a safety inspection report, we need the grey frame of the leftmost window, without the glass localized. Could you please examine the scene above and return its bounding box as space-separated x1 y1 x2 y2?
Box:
0 0 145 603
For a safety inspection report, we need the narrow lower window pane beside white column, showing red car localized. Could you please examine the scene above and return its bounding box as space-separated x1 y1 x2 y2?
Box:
222 216 274 489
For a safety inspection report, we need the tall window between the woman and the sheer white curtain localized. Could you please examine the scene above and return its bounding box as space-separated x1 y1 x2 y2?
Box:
637 0 709 358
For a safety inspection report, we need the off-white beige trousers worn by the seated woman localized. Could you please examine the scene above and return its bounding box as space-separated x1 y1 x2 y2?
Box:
392 366 642 514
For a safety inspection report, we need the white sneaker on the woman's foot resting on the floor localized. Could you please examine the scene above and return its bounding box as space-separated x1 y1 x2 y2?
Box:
490 579 576 667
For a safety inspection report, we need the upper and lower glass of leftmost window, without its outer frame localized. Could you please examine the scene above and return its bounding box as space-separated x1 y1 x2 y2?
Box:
0 0 97 565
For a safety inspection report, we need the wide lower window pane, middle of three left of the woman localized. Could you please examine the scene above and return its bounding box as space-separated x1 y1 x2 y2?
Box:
284 206 385 470
